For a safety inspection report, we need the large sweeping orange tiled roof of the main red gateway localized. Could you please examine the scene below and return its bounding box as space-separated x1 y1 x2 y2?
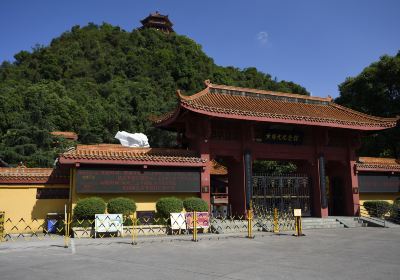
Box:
154 81 399 130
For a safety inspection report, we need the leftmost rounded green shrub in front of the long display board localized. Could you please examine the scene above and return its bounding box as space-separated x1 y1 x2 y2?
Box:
74 197 106 220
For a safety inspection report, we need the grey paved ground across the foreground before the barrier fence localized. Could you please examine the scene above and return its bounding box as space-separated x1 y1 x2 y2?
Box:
0 228 400 280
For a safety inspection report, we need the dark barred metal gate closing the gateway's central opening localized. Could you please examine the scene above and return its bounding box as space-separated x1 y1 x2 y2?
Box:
252 174 311 216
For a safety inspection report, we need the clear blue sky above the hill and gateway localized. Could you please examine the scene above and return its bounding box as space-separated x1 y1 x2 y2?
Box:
0 0 400 97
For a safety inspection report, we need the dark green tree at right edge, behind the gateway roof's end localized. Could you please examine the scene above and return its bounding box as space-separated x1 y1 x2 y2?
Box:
336 52 400 158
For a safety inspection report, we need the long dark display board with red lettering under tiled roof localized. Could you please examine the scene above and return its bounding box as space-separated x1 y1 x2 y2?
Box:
76 166 200 193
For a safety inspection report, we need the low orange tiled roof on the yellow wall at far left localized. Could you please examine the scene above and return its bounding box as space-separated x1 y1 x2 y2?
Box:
0 167 69 184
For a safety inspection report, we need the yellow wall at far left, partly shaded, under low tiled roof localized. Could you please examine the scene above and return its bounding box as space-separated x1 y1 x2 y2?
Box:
0 184 69 232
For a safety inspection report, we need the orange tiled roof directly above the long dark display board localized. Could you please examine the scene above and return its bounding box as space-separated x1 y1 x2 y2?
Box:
60 144 206 165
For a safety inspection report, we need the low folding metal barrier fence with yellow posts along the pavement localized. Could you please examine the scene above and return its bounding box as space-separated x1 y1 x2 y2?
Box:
0 209 295 247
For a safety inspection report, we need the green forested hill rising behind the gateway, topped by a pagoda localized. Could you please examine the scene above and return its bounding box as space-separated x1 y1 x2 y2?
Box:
0 24 308 166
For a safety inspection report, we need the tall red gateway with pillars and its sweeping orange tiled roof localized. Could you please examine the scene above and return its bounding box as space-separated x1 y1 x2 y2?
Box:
156 81 399 217
